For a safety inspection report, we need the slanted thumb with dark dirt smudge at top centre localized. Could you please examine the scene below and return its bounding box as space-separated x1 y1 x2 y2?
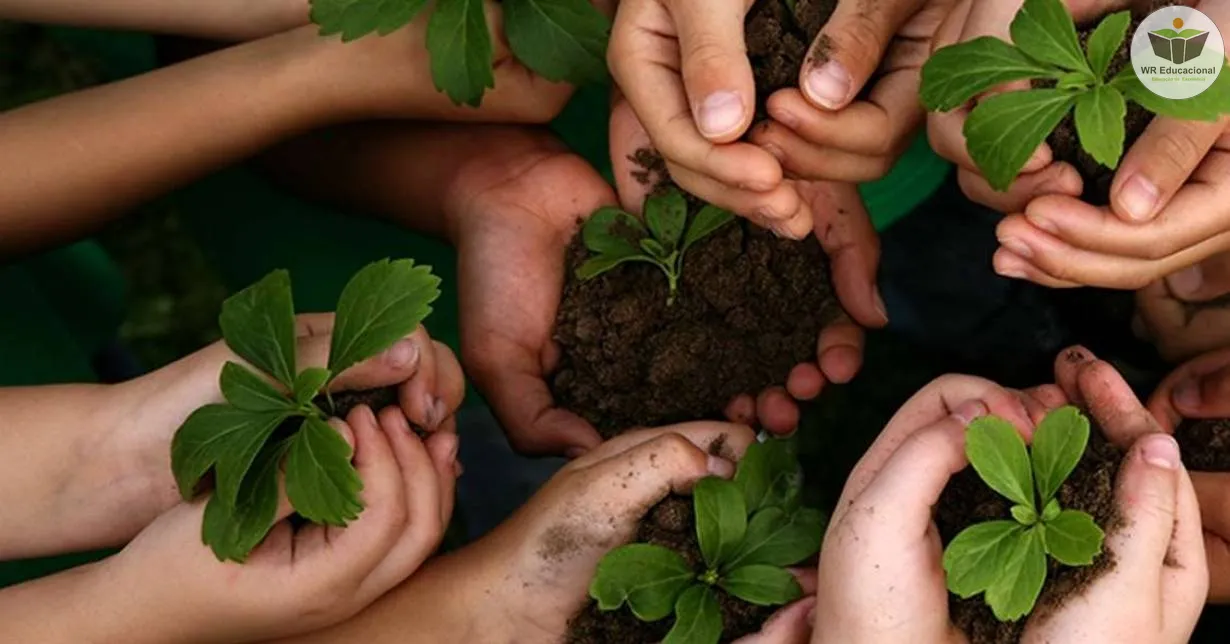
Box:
798 0 923 109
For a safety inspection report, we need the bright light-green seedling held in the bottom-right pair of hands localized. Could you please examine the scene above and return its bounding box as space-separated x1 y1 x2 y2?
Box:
943 407 1105 622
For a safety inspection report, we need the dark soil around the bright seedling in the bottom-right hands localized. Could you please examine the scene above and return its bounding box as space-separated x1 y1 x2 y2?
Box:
935 428 1123 644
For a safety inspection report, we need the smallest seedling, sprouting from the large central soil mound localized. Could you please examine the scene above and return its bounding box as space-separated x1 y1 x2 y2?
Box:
577 190 734 305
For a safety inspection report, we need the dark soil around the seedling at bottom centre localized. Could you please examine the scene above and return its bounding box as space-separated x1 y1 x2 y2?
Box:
565 495 776 644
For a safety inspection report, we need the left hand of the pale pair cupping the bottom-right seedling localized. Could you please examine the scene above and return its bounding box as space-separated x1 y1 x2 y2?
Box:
813 376 1065 643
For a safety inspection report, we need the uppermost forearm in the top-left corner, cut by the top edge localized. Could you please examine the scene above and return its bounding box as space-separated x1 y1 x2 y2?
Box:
0 0 309 41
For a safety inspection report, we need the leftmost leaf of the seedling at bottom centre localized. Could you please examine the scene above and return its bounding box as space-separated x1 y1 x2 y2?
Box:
589 543 696 622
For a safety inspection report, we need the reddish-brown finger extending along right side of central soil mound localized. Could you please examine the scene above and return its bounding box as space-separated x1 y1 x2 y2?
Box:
800 182 888 328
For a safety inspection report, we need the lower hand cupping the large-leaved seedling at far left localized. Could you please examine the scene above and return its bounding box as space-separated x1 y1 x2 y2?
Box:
105 407 458 642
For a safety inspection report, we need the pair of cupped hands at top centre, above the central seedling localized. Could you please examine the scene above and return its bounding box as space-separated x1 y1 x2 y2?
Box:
608 0 947 238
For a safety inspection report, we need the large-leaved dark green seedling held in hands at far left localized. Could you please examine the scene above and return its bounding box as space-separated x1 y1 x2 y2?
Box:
171 259 440 562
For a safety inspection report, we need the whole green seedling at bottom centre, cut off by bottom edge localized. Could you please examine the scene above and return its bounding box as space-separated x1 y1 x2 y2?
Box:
589 439 825 644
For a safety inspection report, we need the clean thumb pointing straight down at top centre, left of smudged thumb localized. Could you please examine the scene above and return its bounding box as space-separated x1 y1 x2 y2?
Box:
669 0 756 143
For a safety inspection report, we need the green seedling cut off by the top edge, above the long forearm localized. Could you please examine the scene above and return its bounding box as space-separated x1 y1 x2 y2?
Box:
311 0 610 107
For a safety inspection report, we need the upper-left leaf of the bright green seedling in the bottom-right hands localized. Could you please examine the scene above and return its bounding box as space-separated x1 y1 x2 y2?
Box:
966 415 1036 508
